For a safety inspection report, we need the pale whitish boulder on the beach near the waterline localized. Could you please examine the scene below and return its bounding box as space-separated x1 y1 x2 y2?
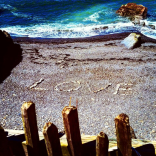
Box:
121 33 141 49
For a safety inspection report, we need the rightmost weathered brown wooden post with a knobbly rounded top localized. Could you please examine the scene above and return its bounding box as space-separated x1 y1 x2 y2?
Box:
115 113 132 156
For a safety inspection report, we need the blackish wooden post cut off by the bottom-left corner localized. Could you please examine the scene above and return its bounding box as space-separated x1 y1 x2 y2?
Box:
0 126 13 156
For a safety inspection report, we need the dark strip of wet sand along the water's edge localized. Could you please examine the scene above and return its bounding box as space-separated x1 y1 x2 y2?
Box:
12 31 156 44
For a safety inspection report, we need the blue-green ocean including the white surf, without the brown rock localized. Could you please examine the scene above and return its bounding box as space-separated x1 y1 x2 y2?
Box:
0 0 156 39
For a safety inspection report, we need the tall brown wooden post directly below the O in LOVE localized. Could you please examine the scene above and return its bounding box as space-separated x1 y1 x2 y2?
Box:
62 106 82 156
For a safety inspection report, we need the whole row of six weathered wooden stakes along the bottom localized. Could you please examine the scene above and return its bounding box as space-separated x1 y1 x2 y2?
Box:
0 102 136 156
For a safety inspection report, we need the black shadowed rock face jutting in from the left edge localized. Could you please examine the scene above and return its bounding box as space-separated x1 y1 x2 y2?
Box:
0 30 22 83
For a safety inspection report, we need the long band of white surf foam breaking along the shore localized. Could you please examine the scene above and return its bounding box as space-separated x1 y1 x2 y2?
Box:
1 22 156 39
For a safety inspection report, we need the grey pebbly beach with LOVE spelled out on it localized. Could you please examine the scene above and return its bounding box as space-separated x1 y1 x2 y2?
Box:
0 33 156 140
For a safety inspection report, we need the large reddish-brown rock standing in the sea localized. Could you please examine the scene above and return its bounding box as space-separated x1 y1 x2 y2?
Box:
116 3 147 18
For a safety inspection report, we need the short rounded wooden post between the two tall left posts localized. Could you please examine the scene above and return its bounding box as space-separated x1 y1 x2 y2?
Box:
43 122 62 156
